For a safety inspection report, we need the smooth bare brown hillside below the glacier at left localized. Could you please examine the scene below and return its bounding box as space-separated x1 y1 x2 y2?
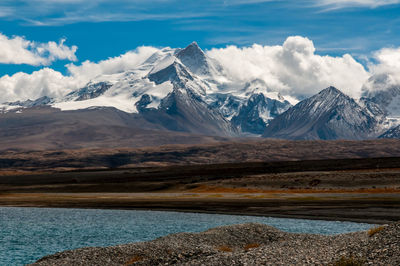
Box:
0 107 224 150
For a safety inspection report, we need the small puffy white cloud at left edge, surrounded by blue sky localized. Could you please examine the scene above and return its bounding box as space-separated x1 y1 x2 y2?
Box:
0 33 78 66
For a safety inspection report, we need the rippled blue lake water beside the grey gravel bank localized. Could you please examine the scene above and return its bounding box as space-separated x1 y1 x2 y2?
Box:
0 207 373 265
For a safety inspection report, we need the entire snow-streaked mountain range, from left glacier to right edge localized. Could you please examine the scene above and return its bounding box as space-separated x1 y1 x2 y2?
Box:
0 42 390 139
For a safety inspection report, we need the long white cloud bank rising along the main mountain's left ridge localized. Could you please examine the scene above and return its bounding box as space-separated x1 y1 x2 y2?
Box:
0 47 158 103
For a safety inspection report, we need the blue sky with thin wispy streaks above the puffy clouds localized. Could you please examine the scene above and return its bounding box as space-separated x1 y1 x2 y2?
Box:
0 0 400 76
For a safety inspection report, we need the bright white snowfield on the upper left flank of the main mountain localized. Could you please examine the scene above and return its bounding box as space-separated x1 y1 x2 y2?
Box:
53 44 209 113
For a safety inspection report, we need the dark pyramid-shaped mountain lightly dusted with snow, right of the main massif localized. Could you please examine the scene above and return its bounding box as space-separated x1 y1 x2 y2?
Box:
263 87 381 140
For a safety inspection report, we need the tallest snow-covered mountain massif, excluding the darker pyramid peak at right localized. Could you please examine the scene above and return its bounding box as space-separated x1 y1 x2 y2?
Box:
1 42 291 136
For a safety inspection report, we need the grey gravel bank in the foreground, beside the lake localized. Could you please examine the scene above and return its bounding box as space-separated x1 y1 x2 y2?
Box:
32 222 400 265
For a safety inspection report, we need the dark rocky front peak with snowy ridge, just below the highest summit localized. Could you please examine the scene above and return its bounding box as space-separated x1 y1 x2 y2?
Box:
140 50 237 136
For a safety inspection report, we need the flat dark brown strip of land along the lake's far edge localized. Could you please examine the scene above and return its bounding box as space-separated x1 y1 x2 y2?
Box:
0 195 400 224
